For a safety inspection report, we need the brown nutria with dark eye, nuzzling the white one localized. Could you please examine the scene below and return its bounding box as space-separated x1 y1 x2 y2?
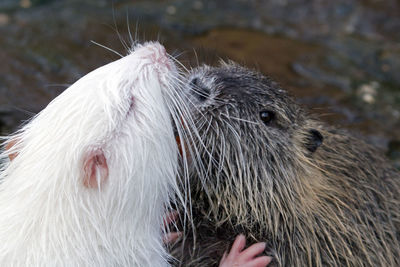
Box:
173 63 400 266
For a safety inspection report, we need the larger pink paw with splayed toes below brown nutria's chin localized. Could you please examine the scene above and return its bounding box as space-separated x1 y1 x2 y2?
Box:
219 235 272 267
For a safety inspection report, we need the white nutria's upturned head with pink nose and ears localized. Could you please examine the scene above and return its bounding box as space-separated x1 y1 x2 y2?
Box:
1 43 178 197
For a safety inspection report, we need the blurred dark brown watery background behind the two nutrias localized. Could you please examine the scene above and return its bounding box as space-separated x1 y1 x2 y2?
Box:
0 0 400 168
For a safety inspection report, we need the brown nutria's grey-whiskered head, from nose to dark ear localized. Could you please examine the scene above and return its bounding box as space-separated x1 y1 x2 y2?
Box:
186 63 323 225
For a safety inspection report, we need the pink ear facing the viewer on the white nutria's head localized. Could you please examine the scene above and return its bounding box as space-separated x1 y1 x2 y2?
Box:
83 150 108 188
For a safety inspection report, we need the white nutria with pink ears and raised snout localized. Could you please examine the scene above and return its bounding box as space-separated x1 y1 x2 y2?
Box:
0 43 188 267
